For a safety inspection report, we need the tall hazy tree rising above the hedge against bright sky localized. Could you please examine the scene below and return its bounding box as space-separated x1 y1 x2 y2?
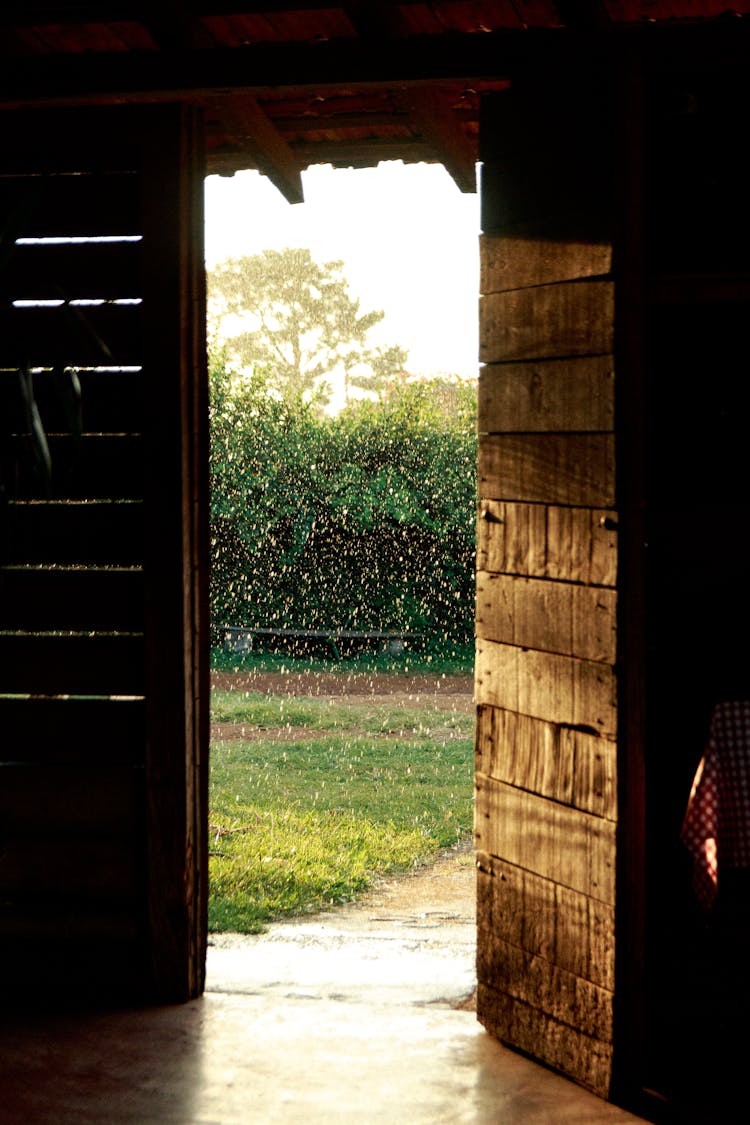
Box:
208 248 407 403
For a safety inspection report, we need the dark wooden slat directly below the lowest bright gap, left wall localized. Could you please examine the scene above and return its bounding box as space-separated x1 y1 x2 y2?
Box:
0 693 146 766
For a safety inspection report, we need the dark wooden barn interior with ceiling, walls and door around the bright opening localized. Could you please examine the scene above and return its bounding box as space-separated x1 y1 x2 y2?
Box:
0 0 750 1121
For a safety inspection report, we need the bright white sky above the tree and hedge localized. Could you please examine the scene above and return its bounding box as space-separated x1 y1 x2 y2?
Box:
206 161 479 377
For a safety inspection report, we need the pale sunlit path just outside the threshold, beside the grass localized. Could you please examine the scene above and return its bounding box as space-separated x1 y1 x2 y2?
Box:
208 840 476 1011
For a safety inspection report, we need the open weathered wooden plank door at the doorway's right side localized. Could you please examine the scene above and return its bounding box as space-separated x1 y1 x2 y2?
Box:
476 83 617 1095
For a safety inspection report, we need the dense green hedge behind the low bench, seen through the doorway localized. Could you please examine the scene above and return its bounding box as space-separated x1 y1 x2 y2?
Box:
210 365 477 650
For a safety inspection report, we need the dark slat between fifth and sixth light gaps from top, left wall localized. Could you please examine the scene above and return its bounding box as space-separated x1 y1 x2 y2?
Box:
3 501 144 566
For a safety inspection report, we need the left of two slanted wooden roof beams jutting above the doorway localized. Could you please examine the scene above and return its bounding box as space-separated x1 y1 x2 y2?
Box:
212 98 305 204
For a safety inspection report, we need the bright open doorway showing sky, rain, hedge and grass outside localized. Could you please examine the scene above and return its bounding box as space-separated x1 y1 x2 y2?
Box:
201 164 478 1012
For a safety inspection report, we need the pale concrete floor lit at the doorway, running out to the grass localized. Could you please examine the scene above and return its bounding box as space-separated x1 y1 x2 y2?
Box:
0 855 641 1125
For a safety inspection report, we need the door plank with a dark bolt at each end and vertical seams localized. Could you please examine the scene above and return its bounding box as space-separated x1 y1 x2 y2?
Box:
477 500 617 586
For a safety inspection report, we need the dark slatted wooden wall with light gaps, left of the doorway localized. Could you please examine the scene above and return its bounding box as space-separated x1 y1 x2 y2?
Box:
0 107 206 999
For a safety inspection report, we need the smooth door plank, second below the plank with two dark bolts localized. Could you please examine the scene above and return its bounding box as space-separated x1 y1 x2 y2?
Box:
475 640 617 739
